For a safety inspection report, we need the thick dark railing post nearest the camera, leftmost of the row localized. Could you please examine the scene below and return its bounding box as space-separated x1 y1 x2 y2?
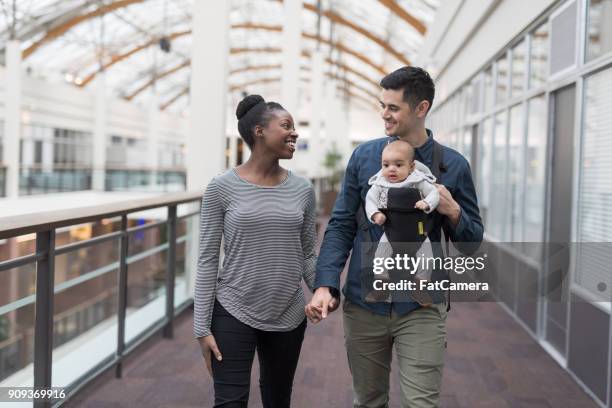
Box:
34 229 55 408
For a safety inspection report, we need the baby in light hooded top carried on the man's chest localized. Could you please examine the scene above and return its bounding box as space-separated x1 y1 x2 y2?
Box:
365 140 440 301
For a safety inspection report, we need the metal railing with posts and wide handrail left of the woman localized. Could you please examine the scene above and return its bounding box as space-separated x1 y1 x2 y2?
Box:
0 192 202 407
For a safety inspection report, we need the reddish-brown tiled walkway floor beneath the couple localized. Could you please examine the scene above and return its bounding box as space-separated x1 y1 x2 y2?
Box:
68 303 596 408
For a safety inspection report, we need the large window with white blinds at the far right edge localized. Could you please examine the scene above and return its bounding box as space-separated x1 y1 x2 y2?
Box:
575 69 612 299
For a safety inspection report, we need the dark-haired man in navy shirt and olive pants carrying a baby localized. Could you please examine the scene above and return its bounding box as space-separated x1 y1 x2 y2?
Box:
306 67 483 408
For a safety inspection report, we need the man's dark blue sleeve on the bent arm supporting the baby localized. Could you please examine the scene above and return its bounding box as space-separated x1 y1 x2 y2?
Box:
446 162 483 255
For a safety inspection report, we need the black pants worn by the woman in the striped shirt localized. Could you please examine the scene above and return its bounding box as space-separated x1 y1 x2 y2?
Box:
211 301 306 408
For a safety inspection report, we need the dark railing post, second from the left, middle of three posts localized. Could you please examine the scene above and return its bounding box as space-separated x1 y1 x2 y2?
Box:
115 215 129 378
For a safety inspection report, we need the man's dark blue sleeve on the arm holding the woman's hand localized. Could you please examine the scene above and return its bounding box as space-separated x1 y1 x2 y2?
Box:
315 152 361 290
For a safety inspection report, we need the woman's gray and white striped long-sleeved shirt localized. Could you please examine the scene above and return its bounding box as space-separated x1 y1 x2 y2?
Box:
193 169 316 337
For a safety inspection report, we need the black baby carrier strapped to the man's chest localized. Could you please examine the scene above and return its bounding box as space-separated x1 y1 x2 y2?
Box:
357 140 450 309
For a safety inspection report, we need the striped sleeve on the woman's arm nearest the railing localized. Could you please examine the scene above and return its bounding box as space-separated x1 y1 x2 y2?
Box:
193 179 224 337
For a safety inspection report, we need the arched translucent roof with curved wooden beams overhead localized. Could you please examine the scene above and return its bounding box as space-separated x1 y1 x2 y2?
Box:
0 0 437 109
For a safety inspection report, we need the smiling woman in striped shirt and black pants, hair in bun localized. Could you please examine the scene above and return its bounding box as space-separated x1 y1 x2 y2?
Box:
194 95 316 407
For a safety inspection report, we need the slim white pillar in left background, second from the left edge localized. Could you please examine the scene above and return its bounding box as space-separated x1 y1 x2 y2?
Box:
92 71 108 191
